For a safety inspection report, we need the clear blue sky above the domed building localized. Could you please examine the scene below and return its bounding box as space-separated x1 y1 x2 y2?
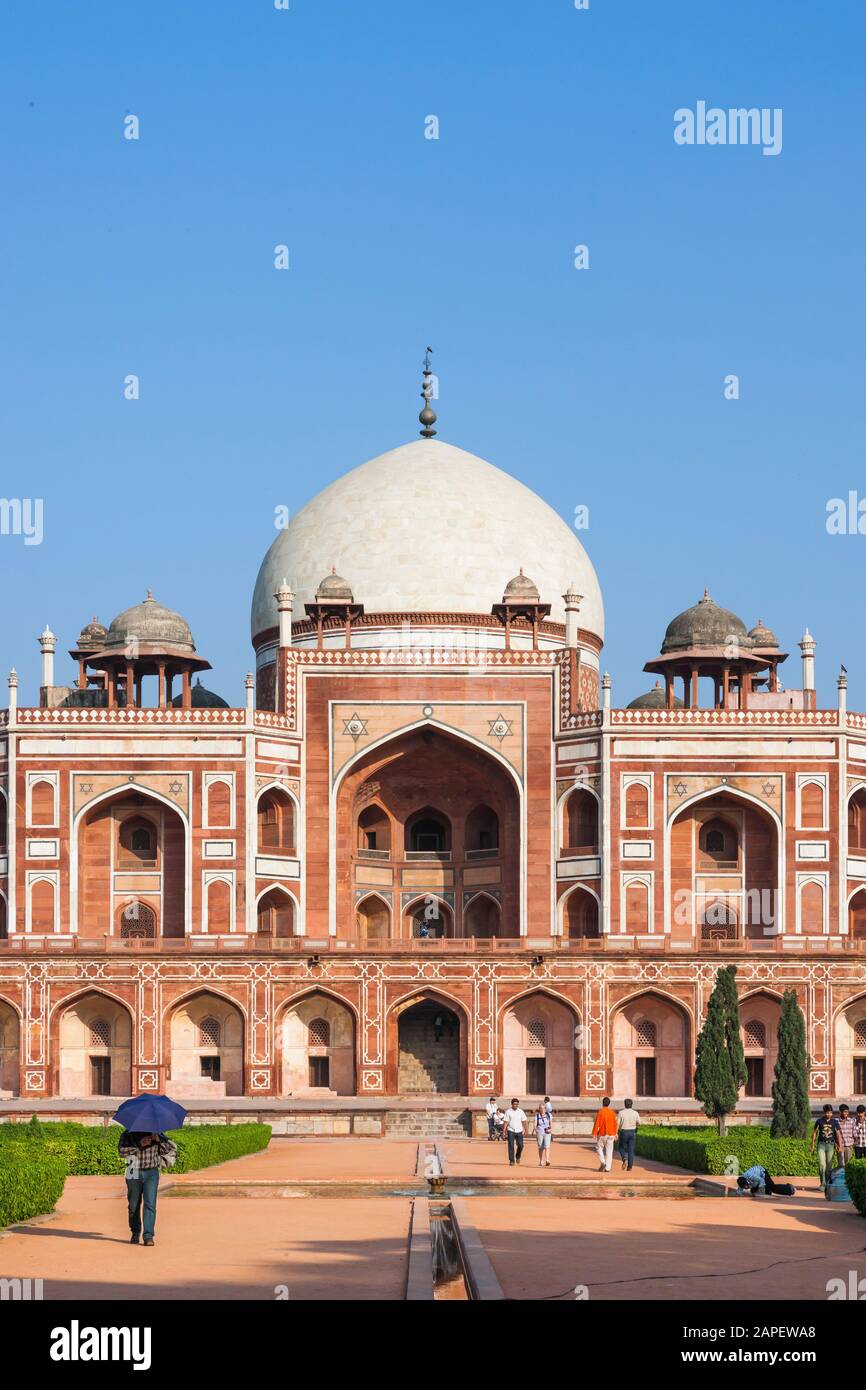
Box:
0 0 866 709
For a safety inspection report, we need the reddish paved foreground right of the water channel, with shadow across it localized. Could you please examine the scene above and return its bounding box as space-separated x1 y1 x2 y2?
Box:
464 1194 866 1301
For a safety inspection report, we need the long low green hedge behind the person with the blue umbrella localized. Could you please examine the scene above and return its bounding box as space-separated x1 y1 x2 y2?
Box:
0 1120 271 1176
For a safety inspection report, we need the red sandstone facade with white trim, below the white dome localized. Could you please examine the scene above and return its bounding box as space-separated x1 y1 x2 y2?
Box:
0 439 866 1099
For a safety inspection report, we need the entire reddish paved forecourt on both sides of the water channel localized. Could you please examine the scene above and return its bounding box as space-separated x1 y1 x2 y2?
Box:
0 1138 866 1304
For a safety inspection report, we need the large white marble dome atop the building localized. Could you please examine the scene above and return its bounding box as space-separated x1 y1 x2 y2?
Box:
252 439 605 641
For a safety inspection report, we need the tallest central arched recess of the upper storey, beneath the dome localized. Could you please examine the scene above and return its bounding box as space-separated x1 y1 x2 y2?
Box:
336 728 520 941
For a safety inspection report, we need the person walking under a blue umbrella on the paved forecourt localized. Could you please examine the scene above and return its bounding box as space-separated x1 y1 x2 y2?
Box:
114 1095 186 1245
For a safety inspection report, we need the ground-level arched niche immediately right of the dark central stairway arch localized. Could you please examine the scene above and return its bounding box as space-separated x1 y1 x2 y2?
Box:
502 992 580 1097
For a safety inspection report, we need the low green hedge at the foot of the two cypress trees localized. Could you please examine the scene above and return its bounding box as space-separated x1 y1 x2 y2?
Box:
637 1125 817 1177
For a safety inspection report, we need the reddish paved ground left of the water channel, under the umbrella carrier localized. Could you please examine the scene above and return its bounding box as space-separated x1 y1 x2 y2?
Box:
0 1165 411 1301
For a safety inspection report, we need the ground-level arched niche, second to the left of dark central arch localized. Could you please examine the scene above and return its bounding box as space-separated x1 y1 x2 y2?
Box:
167 991 243 1098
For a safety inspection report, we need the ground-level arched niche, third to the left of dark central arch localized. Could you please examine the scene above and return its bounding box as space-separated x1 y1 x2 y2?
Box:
58 992 132 1099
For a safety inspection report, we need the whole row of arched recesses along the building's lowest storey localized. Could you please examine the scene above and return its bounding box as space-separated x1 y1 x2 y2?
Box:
0 990 866 1101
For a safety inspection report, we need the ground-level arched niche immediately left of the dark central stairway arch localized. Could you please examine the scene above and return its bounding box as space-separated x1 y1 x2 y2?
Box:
281 994 354 1095
